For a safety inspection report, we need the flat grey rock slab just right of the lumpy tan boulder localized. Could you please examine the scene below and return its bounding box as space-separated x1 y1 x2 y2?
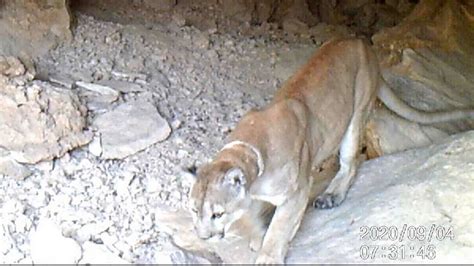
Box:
89 100 171 159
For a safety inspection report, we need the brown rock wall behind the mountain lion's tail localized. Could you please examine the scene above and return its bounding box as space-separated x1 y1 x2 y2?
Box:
367 0 474 157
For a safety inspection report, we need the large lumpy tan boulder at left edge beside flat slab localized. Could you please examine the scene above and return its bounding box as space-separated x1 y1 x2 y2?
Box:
0 61 91 164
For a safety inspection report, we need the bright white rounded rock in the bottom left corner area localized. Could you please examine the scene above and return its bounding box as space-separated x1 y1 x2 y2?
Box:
30 219 82 264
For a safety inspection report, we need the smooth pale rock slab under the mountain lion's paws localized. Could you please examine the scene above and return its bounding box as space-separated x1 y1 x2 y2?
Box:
156 131 474 263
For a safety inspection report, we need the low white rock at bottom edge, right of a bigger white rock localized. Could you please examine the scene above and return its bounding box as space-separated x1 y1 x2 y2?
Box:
79 241 130 265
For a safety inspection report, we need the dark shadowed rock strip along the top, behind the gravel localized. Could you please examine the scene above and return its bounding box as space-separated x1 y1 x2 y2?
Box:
73 0 415 36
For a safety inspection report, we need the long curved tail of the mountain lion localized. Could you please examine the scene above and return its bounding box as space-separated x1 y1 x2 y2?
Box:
378 80 474 124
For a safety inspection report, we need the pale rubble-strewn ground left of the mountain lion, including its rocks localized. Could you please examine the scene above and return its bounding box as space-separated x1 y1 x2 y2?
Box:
0 11 342 263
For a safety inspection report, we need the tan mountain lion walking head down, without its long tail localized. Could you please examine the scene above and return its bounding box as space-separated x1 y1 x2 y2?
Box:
191 39 474 263
